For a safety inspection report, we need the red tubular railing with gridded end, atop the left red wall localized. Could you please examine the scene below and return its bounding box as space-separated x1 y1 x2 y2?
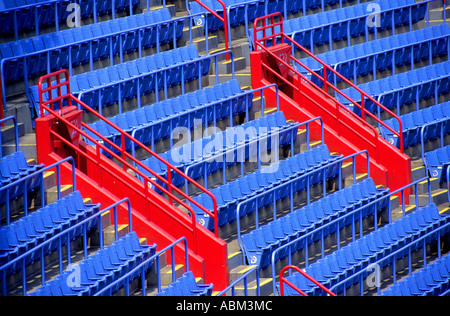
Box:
39 70 218 245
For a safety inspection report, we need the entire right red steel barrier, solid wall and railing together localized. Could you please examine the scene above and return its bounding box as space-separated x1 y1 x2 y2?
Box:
250 13 412 194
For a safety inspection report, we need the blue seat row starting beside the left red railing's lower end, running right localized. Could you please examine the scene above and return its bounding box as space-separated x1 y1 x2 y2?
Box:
192 145 341 231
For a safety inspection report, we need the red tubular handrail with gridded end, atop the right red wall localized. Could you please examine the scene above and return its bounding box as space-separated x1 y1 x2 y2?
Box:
253 12 404 153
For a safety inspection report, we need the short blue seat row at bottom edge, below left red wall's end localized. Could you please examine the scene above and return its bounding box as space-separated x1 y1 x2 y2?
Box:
155 271 213 296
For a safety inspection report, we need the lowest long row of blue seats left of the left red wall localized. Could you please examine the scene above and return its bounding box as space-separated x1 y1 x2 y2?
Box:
29 232 156 296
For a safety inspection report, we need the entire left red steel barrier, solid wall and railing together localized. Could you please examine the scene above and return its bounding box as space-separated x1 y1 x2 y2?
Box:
36 70 228 289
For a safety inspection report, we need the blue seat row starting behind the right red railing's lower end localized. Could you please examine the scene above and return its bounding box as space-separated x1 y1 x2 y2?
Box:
380 102 450 148
